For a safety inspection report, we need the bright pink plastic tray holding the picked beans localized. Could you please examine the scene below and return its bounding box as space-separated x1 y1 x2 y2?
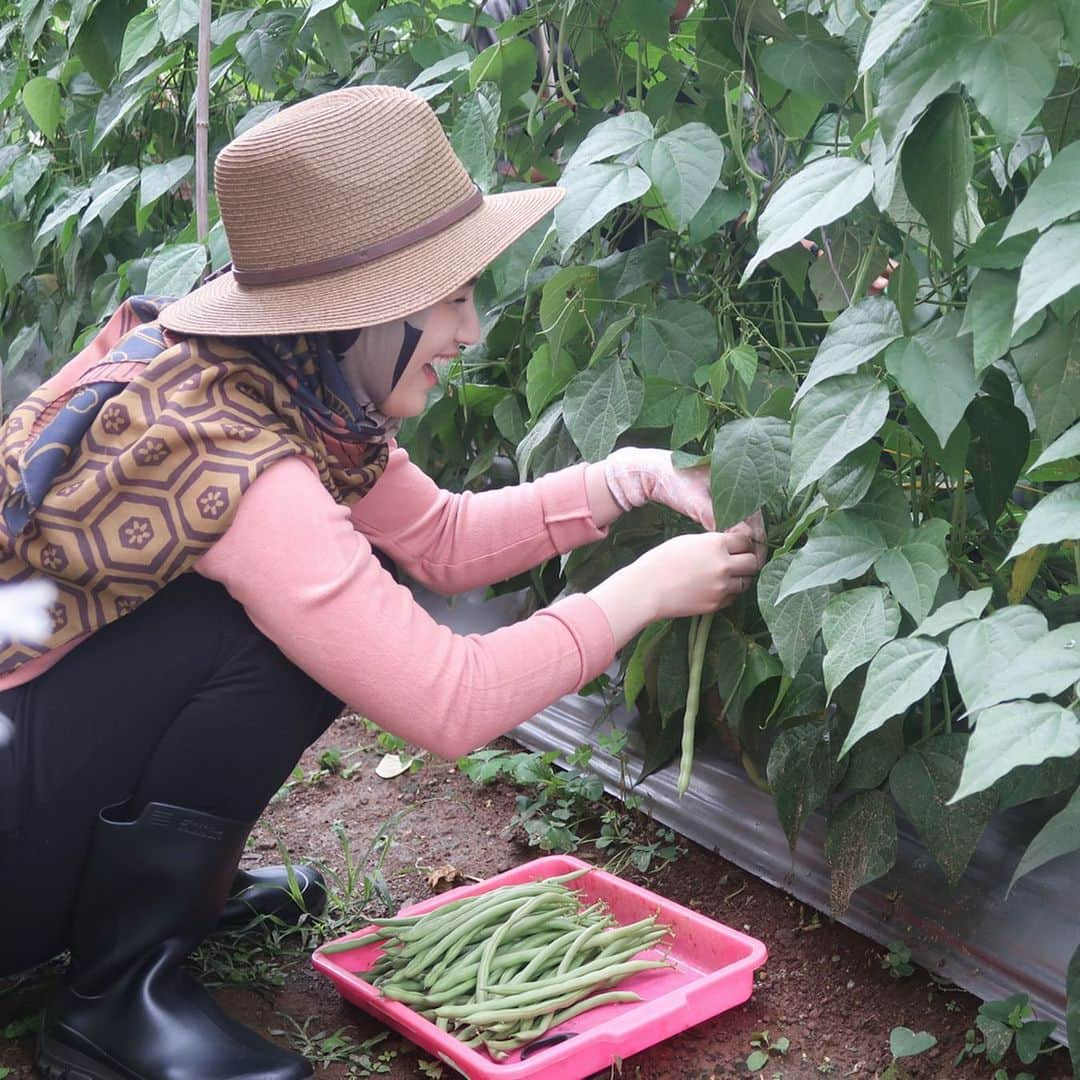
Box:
312 855 766 1080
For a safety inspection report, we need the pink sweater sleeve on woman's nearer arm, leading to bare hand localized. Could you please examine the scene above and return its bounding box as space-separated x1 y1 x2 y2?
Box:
195 458 615 758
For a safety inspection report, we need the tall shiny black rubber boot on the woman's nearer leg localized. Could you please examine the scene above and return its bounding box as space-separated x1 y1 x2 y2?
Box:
37 802 313 1080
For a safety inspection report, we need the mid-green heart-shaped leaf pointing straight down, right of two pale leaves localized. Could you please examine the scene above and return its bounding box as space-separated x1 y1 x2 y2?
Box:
885 315 978 446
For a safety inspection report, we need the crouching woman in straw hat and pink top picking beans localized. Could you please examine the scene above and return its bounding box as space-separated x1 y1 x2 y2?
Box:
0 86 764 1080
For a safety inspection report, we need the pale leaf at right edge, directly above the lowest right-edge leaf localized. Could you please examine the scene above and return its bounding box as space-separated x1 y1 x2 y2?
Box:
950 701 1080 802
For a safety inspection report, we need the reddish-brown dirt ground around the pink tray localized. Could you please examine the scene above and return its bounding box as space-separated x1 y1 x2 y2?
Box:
0 717 1071 1080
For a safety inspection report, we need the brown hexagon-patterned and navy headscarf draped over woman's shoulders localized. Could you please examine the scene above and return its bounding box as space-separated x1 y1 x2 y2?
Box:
0 297 403 674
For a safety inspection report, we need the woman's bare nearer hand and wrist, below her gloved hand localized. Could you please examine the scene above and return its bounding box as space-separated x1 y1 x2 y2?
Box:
589 522 766 648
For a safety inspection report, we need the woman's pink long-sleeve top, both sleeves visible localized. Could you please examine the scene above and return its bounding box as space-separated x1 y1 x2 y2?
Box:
0 448 615 758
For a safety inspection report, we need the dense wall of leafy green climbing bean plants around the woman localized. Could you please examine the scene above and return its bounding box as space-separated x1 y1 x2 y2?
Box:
0 0 1080 1061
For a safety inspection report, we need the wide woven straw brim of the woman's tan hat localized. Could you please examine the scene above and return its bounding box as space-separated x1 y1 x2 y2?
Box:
161 188 564 337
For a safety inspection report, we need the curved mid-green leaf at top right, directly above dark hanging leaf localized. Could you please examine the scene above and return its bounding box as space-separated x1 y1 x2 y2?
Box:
877 4 980 157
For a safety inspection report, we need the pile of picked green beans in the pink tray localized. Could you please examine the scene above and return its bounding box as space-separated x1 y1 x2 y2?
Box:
322 867 670 1062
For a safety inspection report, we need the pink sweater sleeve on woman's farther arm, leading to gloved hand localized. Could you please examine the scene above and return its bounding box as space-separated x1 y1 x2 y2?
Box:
352 448 607 594
